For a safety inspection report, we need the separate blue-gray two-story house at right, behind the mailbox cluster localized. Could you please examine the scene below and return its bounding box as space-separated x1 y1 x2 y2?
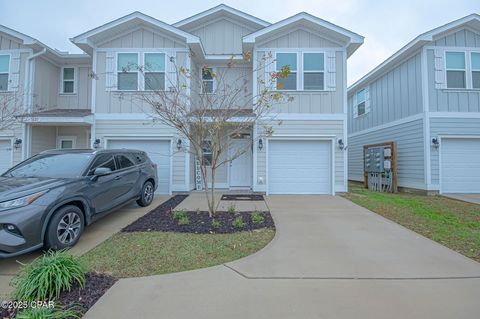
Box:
348 14 480 193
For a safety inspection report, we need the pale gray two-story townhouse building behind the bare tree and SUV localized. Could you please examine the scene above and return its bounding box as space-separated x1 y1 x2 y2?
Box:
0 5 363 194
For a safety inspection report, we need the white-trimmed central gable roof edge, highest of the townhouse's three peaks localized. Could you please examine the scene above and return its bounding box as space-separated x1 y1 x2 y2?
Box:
173 3 270 29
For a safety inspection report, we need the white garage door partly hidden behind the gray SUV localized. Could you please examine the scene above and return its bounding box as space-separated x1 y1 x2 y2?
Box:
107 139 170 194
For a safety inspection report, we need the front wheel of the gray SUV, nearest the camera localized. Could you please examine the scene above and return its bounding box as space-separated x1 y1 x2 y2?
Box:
45 205 85 250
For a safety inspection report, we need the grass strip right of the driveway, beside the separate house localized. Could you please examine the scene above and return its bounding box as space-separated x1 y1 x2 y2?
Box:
344 184 480 261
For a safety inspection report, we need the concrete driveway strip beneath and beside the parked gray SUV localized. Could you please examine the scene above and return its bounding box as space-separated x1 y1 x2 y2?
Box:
0 195 170 301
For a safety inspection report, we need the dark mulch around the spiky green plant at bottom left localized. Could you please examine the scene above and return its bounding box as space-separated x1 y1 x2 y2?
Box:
0 273 117 319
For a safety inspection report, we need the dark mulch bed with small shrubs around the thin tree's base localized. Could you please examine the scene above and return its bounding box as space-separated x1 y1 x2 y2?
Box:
123 209 275 234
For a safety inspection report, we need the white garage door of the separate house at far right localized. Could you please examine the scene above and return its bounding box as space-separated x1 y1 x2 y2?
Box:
440 138 480 193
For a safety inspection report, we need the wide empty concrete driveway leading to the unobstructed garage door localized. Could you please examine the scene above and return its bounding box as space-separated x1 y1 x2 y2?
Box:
80 196 480 319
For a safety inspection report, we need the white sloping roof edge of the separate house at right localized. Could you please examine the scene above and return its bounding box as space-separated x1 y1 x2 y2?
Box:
348 13 480 94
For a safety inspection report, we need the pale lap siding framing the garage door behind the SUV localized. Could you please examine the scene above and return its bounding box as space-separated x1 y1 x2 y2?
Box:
95 120 188 191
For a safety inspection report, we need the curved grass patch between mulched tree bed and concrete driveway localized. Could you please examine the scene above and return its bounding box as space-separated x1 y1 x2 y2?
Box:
82 229 275 278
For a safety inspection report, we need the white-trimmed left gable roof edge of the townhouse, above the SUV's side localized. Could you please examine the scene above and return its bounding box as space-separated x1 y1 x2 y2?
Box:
70 11 204 54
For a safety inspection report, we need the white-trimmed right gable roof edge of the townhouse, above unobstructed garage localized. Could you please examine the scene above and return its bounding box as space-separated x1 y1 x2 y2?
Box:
243 12 363 56
